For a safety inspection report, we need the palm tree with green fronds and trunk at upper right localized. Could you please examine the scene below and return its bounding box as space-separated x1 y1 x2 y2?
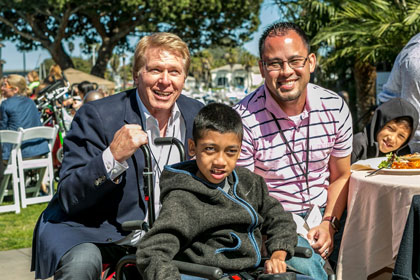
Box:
313 0 420 129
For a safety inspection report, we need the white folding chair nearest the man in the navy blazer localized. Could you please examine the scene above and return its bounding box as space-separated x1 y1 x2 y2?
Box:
17 126 57 208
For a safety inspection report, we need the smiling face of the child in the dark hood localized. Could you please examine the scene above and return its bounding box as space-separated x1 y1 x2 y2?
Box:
376 121 411 154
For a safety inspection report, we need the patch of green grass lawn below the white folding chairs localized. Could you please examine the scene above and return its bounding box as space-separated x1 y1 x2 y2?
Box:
0 203 48 251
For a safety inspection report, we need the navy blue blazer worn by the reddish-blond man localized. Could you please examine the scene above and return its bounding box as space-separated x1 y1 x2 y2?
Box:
31 89 203 279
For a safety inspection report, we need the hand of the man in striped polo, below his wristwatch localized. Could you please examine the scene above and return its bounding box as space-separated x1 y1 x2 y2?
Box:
308 221 334 259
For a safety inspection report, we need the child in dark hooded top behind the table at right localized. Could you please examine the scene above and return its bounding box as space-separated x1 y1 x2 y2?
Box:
351 98 419 164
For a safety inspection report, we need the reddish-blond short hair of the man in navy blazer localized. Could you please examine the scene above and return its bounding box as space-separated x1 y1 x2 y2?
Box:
133 32 190 78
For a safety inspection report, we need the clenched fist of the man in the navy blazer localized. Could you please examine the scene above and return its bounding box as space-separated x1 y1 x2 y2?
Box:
109 124 148 163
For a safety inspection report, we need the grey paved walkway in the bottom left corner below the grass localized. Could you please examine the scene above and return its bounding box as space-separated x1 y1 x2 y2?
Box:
0 248 52 280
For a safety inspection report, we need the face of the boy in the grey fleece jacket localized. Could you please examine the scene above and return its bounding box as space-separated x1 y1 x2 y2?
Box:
188 130 241 184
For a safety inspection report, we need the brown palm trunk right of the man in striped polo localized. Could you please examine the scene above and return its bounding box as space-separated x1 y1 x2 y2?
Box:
354 61 376 131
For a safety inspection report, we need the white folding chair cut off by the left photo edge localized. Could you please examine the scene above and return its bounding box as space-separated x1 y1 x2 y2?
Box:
0 130 22 213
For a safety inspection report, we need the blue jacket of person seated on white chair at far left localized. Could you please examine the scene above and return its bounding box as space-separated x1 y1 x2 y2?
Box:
0 95 50 160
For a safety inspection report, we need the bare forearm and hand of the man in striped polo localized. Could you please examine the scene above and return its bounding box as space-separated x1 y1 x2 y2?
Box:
308 155 350 258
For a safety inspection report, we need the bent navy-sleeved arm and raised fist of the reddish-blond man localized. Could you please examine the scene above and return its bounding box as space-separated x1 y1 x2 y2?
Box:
57 104 148 215
